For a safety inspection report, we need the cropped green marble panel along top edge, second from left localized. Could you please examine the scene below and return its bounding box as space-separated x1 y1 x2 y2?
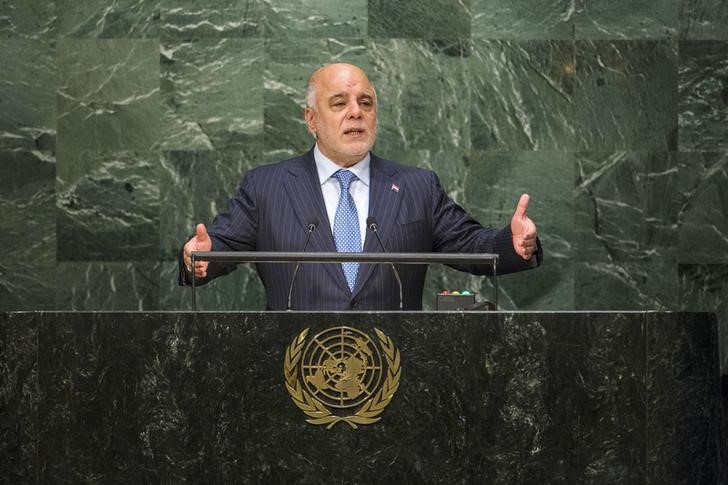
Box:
55 0 160 39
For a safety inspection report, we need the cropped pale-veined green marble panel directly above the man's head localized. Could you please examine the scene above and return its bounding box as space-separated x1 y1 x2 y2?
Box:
262 0 367 40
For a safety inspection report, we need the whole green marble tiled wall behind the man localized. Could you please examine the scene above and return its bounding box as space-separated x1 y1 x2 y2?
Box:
0 0 728 372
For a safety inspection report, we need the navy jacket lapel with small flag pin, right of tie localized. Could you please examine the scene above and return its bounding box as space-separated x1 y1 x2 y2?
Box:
354 154 404 294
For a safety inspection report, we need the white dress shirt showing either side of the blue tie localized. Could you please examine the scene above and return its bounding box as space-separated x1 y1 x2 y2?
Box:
313 144 371 244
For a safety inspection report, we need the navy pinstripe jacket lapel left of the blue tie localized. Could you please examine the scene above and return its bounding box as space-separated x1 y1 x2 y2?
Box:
284 150 349 290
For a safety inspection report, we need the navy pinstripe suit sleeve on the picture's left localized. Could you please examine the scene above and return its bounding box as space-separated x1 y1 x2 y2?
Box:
178 170 258 286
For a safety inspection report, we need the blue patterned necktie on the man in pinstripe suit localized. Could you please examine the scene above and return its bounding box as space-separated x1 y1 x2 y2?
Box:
332 170 361 291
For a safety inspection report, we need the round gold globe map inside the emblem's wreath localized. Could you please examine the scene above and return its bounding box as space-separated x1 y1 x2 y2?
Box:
300 327 384 408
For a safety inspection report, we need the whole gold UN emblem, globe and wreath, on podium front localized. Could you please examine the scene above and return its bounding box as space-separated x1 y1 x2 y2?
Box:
283 327 402 429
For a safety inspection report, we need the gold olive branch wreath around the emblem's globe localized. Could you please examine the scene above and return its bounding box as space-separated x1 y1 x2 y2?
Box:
283 328 402 429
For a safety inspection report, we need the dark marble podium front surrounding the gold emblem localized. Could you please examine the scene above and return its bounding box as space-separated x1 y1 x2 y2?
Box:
0 312 725 484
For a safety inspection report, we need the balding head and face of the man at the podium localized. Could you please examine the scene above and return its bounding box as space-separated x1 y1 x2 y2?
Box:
304 64 377 167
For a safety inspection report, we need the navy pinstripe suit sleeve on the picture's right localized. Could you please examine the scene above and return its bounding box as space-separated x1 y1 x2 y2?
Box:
431 172 543 274
